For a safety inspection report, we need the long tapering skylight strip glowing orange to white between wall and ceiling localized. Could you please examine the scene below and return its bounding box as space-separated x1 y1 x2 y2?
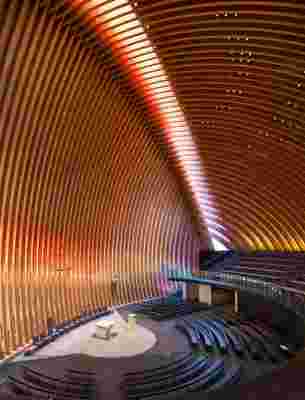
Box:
68 0 216 244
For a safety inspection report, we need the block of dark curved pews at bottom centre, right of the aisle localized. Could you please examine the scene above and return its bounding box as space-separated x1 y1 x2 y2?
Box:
122 353 240 400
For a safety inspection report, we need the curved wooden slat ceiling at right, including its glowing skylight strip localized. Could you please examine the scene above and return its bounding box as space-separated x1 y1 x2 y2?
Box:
39 0 305 250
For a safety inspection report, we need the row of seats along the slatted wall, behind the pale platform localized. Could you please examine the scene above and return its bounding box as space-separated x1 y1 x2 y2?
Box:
24 307 112 356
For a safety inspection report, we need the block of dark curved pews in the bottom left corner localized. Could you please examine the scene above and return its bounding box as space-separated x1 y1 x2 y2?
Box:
6 366 96 400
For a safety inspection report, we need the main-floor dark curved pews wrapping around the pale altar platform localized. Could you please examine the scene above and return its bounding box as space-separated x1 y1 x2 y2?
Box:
0 297 296 400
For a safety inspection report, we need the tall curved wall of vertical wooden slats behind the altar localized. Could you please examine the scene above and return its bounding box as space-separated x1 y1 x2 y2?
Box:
0 0 202 354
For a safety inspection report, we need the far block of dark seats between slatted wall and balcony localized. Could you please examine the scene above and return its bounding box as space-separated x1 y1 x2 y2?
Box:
133 296 208 321
